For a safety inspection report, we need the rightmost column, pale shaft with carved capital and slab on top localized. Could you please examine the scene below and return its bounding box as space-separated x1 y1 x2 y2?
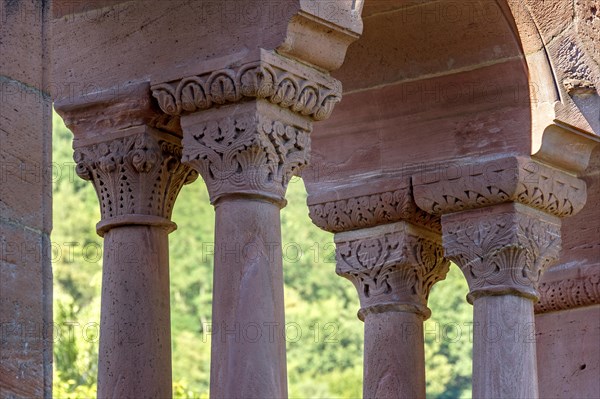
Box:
413 157 586 398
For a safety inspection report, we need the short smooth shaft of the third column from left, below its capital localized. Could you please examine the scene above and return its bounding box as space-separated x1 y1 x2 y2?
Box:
363 312 425 399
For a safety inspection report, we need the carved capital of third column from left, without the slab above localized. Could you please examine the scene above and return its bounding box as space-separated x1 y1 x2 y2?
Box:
335 222 449 320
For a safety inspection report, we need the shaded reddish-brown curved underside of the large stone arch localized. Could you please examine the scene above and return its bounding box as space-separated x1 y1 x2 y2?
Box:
307 1 531 189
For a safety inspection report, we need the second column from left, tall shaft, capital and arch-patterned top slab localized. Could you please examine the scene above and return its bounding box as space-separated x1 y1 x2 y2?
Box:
153 52 341 398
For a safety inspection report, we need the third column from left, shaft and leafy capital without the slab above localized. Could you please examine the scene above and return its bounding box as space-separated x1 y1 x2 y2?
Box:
335 222 449 399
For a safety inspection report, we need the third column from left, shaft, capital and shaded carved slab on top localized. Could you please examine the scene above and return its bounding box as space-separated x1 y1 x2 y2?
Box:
310 185 449 399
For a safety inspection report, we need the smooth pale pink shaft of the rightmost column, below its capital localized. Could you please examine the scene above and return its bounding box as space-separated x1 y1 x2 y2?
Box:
473 295 538 399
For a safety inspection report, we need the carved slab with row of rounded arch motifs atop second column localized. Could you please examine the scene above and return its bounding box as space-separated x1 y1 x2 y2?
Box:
152 51 342 121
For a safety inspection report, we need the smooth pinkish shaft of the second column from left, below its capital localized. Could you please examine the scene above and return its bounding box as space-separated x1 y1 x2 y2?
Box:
210 198 287 399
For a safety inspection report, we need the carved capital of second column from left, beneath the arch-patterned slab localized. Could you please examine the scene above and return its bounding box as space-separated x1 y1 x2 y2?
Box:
181 101 312 204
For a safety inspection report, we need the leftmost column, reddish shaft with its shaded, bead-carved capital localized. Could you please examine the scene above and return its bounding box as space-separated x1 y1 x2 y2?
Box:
74 125 197 398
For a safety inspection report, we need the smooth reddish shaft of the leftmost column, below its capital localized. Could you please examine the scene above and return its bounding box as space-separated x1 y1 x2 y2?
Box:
98 226 172 399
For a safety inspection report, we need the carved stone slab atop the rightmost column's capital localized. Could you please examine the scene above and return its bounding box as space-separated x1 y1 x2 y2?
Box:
413 157 587 217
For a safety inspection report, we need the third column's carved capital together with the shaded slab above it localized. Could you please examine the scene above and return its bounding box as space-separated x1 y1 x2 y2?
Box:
308 180 449 321
